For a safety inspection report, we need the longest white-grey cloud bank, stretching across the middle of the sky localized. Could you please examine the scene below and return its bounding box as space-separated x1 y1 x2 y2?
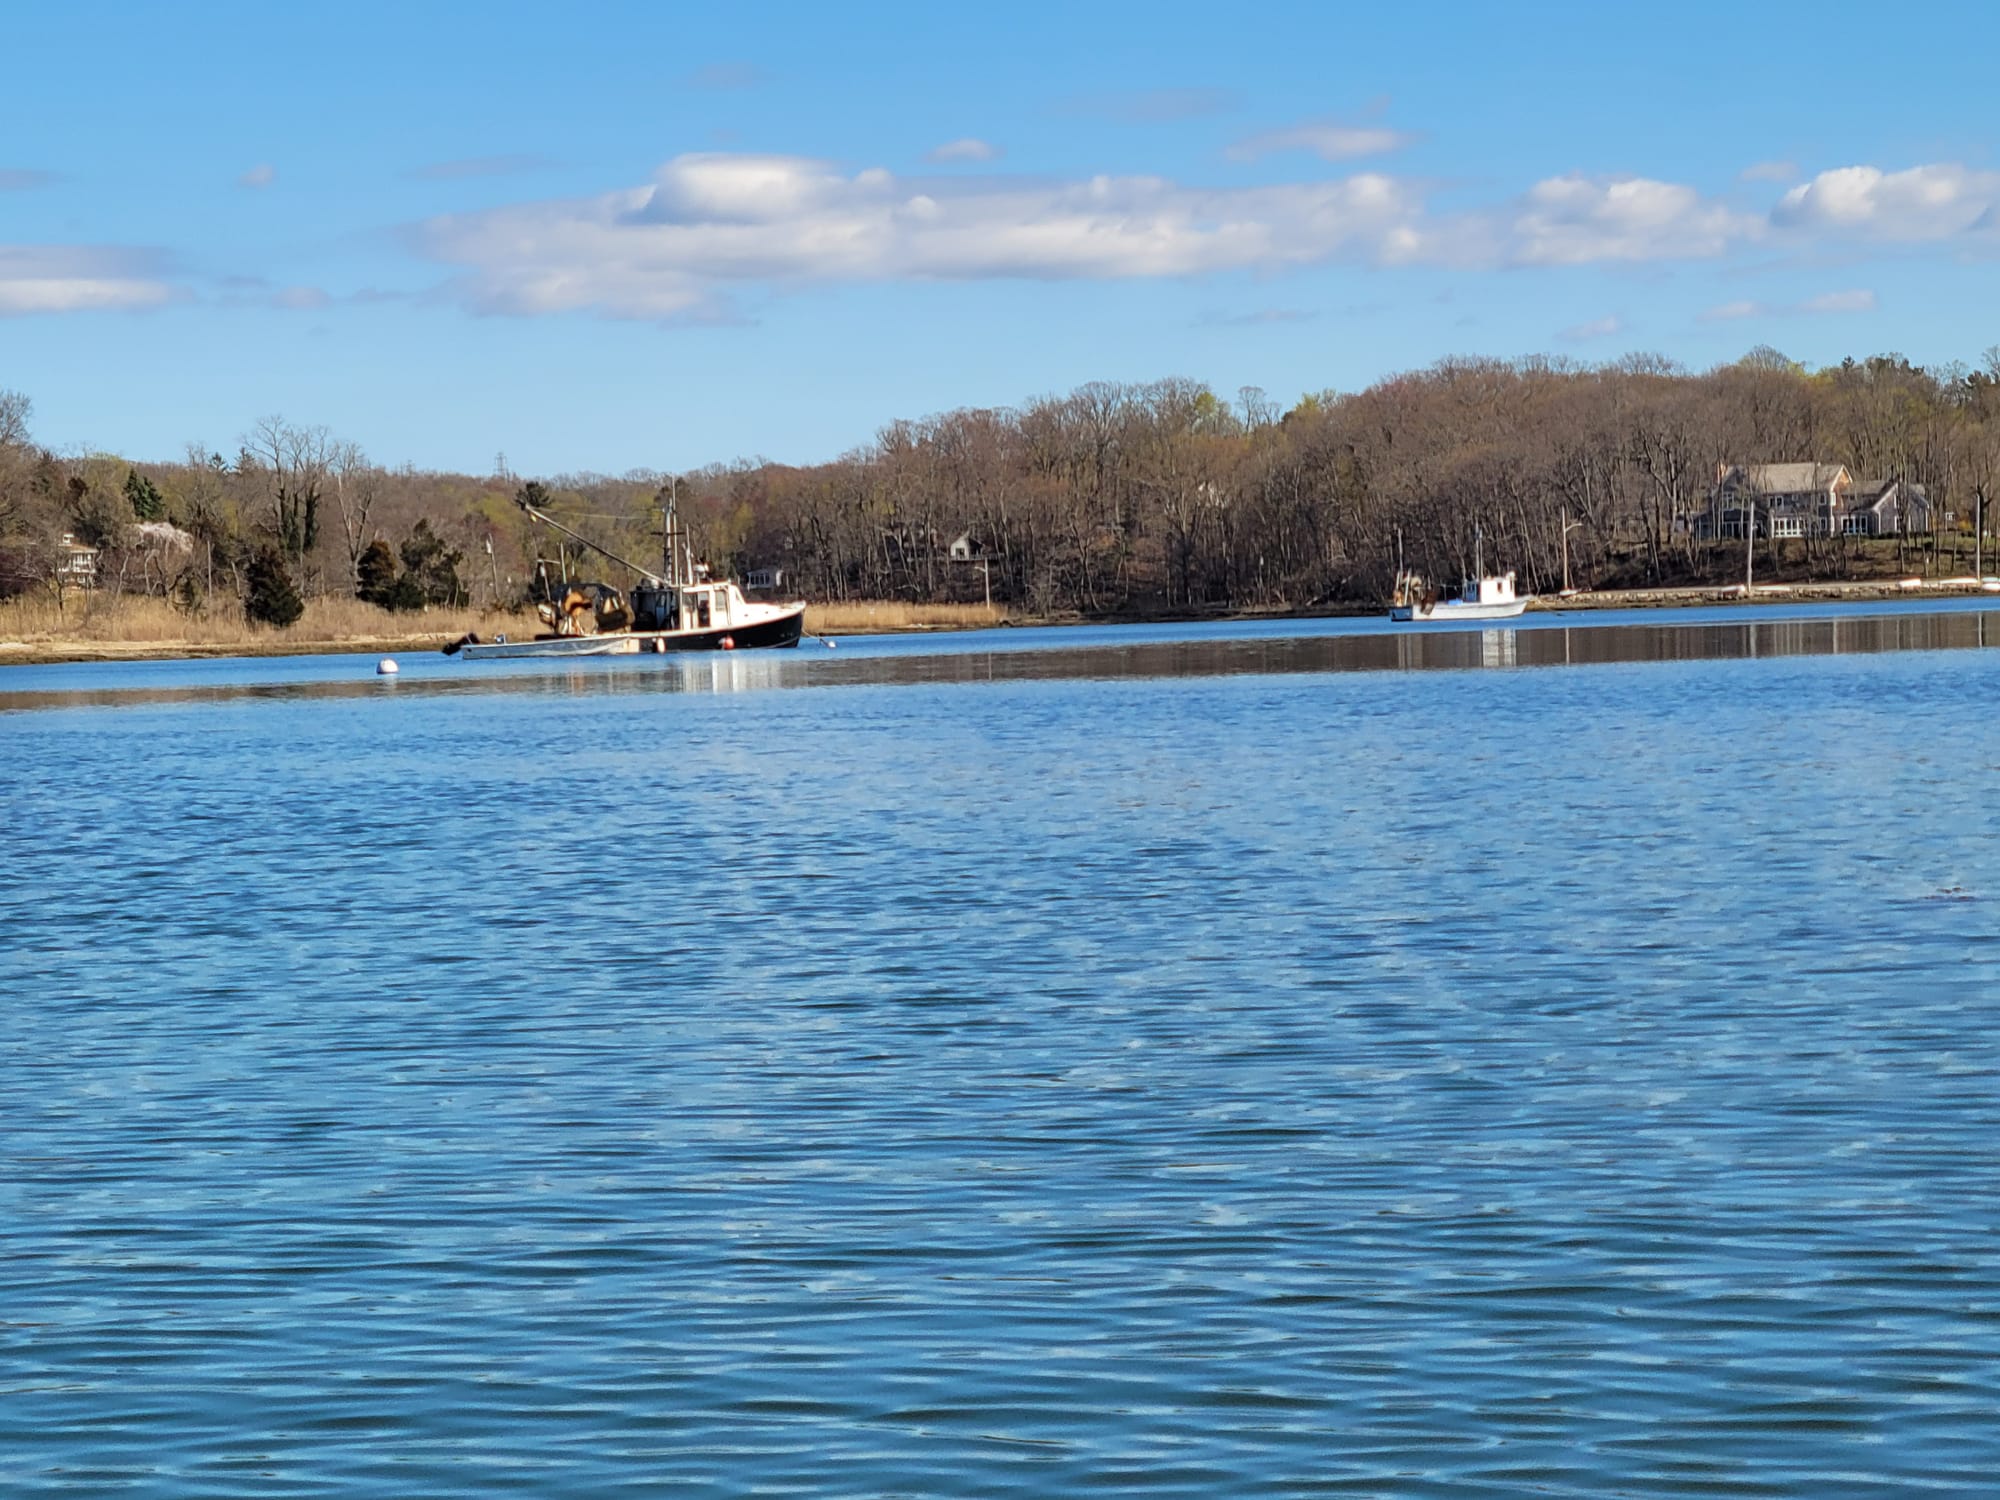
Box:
416 154 1422 318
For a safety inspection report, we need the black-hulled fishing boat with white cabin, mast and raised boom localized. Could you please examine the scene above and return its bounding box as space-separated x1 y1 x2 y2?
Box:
444 496 806 660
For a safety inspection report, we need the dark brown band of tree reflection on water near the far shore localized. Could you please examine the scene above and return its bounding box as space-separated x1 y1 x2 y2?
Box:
11 610 2000 712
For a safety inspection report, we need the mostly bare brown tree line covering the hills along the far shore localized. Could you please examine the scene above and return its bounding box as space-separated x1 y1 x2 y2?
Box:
0 348 2000 624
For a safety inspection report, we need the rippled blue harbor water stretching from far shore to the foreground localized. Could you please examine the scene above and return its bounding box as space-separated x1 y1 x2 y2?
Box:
0 608 2000 1500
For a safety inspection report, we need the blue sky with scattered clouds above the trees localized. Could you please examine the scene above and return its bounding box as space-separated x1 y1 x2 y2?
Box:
0 0 2000 474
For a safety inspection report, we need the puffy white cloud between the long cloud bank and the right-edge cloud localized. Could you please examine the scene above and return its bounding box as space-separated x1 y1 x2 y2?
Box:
1506 174 1762 266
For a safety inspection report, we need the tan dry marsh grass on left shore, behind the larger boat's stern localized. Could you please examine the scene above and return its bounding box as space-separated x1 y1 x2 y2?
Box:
0 594 534 652
